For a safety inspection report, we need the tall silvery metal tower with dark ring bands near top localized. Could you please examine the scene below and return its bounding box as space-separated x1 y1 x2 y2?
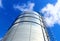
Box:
3 11 49 41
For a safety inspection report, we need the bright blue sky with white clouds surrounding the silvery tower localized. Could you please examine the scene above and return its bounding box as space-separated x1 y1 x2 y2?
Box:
0 0 60 41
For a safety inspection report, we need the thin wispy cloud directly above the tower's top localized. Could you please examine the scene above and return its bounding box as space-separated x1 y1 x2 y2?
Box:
13 2 35 11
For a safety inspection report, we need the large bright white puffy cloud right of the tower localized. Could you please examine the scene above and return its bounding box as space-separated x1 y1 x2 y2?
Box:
41 0 60 27
